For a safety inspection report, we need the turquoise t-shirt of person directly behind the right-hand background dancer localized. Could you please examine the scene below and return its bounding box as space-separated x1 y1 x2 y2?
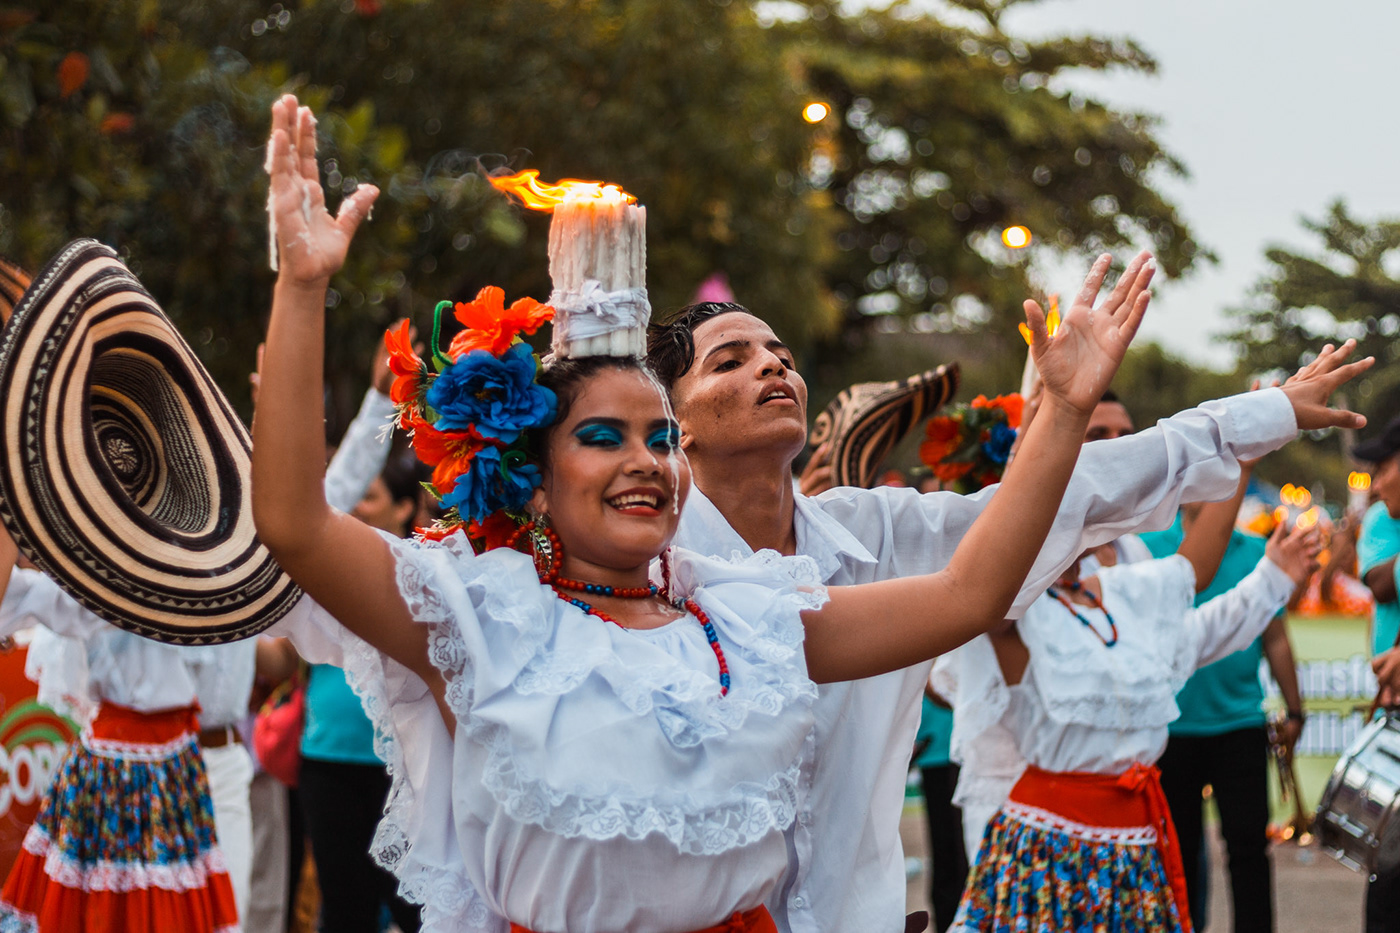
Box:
1141 516 1264 735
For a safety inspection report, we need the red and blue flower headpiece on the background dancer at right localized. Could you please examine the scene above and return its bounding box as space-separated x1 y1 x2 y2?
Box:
918 392 1023 493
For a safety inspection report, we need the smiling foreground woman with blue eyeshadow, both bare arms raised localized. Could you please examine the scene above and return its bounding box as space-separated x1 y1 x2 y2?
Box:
253 88 1151 933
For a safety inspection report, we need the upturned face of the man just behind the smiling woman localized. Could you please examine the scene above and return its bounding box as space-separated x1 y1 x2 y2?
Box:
671 312 806 469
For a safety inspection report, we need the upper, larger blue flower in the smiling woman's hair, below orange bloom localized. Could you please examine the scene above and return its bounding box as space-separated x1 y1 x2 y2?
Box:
427 343 559 444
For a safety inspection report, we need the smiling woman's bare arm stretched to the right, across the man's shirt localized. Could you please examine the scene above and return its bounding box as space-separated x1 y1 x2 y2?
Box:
805 254 1154 681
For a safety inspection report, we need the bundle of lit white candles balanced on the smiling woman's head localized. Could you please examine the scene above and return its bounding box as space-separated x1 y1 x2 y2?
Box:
490 170 651 357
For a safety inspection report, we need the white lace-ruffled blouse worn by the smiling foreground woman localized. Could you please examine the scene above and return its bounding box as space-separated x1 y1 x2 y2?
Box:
280 535 826 933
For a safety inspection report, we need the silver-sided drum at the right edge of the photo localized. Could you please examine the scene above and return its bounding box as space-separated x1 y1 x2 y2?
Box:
1316 710 1400 874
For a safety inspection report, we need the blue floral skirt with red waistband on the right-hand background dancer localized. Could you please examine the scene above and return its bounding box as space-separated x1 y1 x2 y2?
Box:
952 769 1191 933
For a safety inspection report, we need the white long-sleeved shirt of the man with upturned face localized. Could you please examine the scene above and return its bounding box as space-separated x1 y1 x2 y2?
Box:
675 389 1298 933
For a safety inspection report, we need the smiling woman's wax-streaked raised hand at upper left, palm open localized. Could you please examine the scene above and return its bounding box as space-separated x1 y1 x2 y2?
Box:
267 94 379 284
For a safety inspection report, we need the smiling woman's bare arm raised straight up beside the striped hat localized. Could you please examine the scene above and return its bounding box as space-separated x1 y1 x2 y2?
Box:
253 95 442 695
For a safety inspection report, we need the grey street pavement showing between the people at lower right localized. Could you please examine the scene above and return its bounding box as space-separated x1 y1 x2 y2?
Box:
900 800 1366 933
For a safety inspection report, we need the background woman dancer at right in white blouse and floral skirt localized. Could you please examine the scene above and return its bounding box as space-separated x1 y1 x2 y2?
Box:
934 501 1331 933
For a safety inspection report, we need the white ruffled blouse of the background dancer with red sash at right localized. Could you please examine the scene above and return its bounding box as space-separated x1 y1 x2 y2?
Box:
934 555 1294 838
